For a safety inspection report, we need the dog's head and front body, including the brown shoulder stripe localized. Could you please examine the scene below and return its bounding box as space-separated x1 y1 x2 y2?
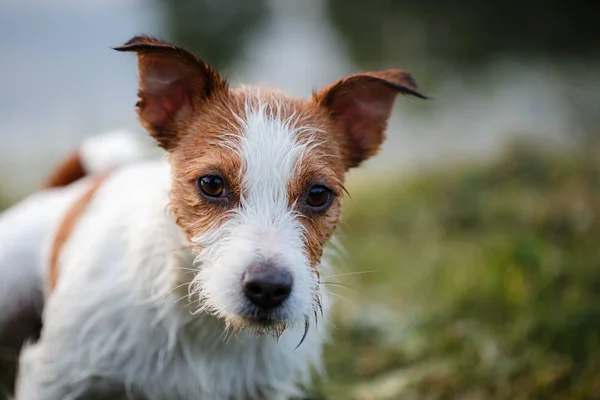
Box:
3 36 426 400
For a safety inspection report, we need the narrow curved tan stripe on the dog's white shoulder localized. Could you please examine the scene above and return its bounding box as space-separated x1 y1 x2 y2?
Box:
48 173 109 290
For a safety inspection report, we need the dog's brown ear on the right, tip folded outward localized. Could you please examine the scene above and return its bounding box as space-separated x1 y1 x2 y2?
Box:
313 69 427 168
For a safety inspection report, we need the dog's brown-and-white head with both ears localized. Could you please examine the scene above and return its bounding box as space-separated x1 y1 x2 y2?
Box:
118 37 424 333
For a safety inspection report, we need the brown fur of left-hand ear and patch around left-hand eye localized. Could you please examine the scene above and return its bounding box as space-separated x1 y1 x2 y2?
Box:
117 36 241 244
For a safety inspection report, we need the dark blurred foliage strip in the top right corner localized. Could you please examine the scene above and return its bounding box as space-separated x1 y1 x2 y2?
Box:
328 0 600 64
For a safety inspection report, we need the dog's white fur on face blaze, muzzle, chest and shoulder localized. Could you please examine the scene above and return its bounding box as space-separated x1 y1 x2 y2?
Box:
12 107 328 400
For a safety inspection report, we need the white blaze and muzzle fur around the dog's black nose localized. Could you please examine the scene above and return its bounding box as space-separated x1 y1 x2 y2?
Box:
194 98 318 326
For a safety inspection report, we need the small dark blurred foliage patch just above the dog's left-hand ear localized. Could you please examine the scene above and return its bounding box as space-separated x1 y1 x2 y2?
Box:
156 0 269 69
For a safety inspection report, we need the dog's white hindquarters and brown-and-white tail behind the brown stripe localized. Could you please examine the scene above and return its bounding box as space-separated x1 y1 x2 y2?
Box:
0 130 152 398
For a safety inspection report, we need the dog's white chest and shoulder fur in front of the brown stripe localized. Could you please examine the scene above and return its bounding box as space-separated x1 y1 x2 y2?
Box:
18 162 322 399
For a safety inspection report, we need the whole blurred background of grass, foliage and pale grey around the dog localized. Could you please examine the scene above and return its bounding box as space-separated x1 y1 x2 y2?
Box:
0 0 600 400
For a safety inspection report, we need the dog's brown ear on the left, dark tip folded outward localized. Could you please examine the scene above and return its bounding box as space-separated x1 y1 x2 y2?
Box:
115 36 227 150
